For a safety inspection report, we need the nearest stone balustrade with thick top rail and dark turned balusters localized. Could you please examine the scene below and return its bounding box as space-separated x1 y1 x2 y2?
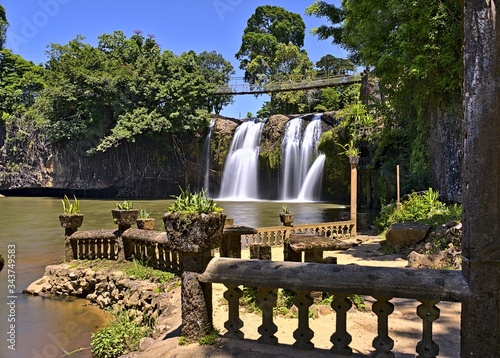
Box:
199 258 470 357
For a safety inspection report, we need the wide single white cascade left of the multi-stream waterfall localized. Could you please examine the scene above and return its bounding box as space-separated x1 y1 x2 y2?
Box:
219 120 264 200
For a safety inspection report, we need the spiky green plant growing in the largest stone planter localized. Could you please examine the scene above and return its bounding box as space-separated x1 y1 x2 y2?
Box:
167 187 223 214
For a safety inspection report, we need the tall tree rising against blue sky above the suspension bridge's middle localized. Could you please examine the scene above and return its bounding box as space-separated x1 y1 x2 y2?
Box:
236 5 305 84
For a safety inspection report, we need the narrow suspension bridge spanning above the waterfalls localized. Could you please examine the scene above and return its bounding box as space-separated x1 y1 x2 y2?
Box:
213 73 365 96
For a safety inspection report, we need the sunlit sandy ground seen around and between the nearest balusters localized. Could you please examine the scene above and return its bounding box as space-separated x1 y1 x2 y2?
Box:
23 235 460 358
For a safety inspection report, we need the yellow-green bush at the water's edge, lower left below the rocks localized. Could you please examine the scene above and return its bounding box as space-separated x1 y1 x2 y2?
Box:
91 311 152 358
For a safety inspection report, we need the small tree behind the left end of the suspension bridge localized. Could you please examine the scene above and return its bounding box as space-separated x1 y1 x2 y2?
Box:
198 51 235 114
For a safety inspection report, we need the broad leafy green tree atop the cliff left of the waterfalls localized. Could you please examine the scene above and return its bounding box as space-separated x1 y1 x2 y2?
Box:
33 31 213 152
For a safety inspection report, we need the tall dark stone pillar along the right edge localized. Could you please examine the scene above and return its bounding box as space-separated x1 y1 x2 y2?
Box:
461 0 500 358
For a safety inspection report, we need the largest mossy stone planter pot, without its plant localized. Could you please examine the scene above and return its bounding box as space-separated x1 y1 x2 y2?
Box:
163 213 227 252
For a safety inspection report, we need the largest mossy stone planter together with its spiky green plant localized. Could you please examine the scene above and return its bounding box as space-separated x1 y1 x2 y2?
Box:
163 188 226 252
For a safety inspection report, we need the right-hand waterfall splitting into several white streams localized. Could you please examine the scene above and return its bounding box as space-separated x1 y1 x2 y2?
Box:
281 115 325 200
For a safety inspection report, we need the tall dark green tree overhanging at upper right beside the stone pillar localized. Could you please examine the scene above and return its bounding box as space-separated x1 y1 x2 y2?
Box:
306 0 462 192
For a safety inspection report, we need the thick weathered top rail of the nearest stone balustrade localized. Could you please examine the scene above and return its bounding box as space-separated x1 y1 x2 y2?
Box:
200 258 470 302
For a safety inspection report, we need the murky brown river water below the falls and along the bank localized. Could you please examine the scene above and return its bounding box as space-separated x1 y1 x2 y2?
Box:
0 197 341 358
